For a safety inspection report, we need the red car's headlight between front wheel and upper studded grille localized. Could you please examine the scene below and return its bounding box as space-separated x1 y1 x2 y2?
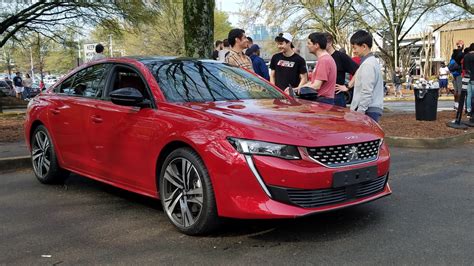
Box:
227 138 301 160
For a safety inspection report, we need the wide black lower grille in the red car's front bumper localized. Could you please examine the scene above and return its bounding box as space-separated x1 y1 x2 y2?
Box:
269 174 388 208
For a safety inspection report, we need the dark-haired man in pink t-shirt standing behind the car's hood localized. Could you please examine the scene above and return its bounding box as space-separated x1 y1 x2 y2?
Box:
285 32 337 104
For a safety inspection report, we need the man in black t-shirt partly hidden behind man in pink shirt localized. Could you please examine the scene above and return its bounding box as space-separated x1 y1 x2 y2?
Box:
324 33 359 107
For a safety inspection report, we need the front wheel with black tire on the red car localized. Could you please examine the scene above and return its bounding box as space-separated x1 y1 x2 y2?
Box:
159 148 220 235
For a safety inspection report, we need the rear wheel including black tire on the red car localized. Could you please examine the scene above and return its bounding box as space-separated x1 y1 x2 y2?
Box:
31 125 69 184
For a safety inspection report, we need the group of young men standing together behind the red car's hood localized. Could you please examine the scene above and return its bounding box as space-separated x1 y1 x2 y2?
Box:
213 29 384 122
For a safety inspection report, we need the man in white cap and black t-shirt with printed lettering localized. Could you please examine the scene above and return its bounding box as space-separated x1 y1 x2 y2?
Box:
270 33 308 90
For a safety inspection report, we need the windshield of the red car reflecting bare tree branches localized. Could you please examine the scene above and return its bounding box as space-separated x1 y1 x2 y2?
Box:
147 60 285 102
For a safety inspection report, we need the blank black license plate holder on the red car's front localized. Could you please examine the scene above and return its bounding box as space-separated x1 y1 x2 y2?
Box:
332 166 377 188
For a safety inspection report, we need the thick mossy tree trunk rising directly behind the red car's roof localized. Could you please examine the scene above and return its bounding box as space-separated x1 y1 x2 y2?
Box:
183 0 215 58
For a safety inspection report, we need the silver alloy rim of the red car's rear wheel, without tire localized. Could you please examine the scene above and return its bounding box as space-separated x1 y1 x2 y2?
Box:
31 131 51 178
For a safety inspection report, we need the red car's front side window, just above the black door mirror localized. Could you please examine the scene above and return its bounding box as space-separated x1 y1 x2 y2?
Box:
107 66 151 100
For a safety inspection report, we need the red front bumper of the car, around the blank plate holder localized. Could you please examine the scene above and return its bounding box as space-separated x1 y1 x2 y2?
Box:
209 139 392 219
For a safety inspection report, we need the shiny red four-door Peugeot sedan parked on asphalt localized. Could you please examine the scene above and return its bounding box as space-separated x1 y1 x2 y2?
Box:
25 57 391 234
